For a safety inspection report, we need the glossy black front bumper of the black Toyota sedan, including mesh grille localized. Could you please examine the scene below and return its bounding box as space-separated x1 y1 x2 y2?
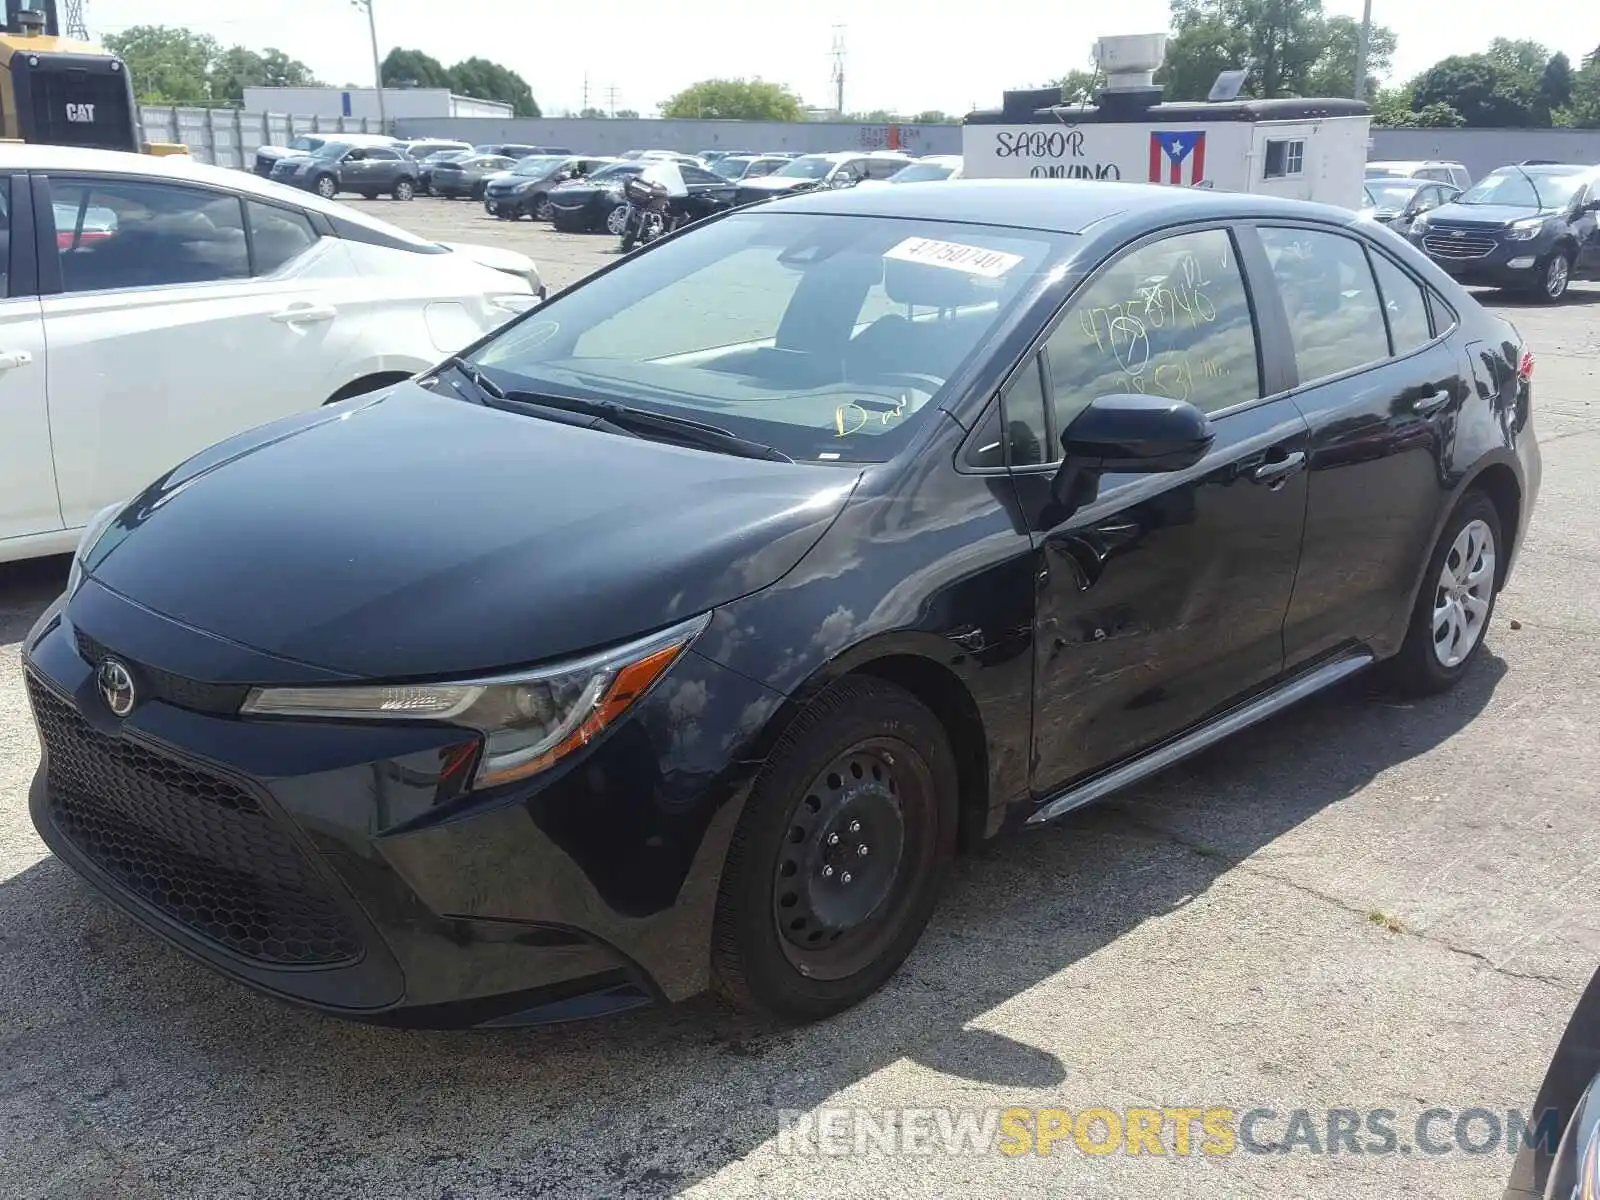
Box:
24 581 770 1027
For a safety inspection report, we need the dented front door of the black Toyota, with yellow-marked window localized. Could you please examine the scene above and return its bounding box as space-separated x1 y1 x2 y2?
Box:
1018 229 1307 795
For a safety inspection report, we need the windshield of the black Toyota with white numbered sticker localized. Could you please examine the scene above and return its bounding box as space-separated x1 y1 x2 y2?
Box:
472 211 1074 462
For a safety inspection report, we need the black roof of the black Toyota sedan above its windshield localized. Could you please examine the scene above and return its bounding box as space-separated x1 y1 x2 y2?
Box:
758 179 1355 234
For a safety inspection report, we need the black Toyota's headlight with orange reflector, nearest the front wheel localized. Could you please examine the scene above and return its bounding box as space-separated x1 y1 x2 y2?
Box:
240 613 710 787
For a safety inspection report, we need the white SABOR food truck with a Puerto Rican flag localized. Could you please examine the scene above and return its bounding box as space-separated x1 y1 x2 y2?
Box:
962 34 1371 208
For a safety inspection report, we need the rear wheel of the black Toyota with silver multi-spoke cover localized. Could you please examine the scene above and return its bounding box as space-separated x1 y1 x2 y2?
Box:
1387 490 1504 696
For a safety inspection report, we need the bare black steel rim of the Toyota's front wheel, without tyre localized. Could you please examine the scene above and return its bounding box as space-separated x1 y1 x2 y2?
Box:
773 738 933 979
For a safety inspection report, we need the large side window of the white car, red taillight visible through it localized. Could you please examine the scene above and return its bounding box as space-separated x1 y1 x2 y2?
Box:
50 178 250 291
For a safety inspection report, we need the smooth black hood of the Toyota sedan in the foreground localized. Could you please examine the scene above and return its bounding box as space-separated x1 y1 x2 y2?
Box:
90 382 859 678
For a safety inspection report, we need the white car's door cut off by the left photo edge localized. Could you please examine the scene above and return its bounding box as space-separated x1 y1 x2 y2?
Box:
0 174 62 544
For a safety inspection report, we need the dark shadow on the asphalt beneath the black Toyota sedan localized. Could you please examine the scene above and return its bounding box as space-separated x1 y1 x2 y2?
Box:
0 544 1506 1195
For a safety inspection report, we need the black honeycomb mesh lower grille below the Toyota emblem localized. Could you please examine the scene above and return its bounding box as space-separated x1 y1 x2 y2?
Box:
27 675 360 966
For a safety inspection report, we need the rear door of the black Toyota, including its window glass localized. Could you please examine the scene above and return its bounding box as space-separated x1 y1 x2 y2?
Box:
1258 224 1469 669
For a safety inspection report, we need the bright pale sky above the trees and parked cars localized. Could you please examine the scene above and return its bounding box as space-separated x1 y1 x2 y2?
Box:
88 0 1600 115
